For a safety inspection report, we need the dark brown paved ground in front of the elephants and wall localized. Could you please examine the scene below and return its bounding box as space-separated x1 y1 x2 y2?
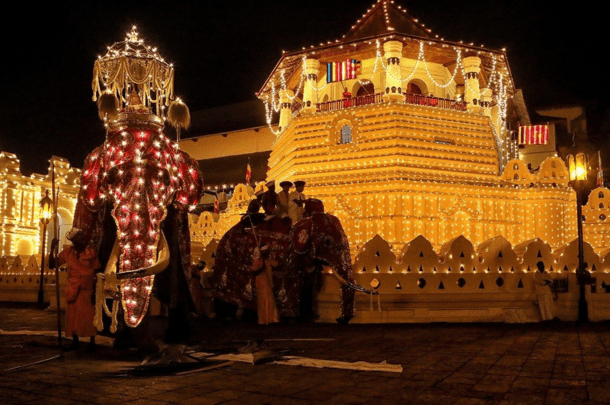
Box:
0 305 610 405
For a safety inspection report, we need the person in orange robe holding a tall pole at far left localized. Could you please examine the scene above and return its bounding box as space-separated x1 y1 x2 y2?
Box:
49 228 101 351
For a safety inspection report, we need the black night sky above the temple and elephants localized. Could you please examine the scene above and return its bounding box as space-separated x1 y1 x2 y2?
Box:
0 0 610 175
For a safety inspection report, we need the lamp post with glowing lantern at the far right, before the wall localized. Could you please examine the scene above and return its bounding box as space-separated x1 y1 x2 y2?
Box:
568 153 589 321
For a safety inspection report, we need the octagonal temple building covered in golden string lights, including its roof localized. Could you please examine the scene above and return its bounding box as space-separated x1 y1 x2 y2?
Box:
195 1 596 254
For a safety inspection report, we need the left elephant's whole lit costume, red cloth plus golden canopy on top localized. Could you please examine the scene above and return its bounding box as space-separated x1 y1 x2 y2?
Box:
74 28 203 340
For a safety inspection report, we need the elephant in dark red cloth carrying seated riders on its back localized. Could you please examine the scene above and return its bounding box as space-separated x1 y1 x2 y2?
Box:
210 208 363 323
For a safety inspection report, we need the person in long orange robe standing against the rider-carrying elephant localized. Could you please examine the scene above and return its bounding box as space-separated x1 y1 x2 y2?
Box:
252 245 280 325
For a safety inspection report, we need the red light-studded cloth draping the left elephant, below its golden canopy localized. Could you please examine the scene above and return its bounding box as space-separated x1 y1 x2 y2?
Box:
74 114 203 334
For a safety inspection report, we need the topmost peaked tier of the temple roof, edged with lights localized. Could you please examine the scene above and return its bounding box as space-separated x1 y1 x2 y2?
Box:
342 0 432 41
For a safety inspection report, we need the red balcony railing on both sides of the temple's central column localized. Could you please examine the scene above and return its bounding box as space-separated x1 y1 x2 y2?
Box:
316 93 466 112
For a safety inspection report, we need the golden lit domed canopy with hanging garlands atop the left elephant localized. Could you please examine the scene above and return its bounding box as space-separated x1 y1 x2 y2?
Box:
92 26 174 120
